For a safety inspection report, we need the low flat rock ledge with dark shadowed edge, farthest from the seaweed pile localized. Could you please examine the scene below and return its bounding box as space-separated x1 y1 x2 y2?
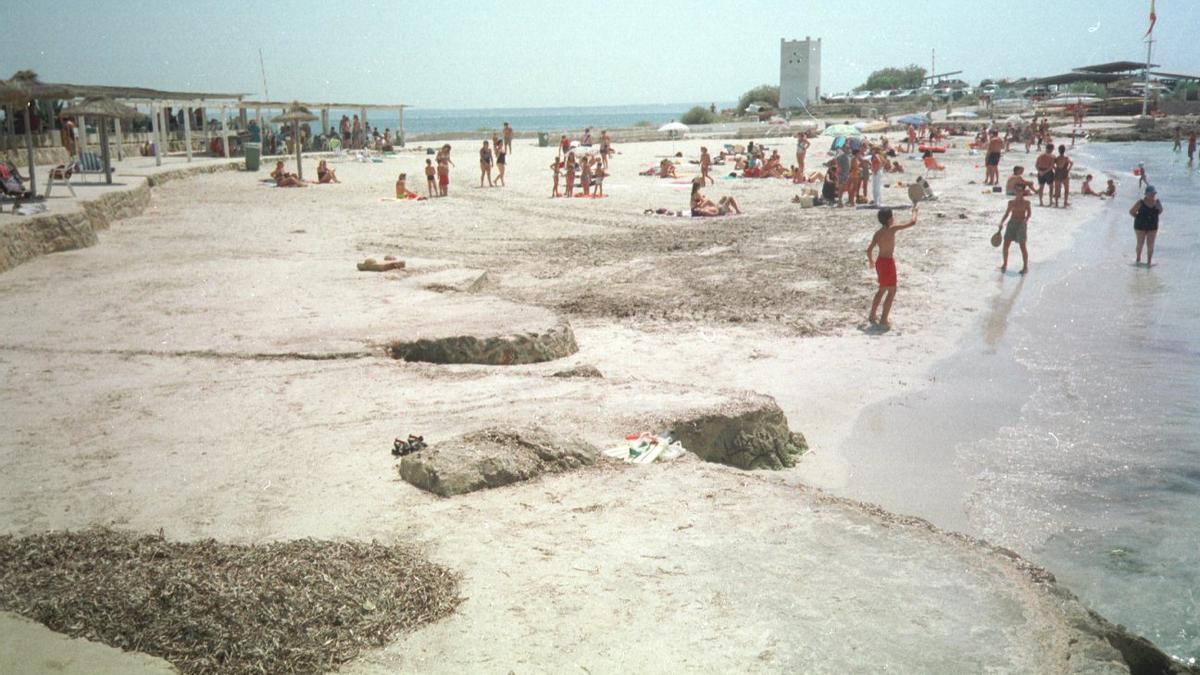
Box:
388 323 580 365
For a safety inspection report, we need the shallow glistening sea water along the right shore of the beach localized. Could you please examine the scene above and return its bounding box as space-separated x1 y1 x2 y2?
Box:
846 143 1200 661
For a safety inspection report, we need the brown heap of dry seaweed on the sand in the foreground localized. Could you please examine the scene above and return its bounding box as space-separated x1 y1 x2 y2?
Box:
0 528 460 673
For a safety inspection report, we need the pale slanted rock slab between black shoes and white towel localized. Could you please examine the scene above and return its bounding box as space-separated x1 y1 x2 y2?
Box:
400 426 600 497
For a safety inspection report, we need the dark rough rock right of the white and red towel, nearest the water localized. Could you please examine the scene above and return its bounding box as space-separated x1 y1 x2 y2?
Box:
671 394 809 468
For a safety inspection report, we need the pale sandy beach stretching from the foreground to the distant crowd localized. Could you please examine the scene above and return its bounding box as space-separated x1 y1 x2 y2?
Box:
0 124 1171 673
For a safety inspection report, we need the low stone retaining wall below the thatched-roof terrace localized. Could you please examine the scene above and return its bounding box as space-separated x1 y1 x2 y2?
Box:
0 162 242 273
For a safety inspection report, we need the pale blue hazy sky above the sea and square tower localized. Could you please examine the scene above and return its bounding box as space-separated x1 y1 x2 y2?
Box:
0 0 1200 108
